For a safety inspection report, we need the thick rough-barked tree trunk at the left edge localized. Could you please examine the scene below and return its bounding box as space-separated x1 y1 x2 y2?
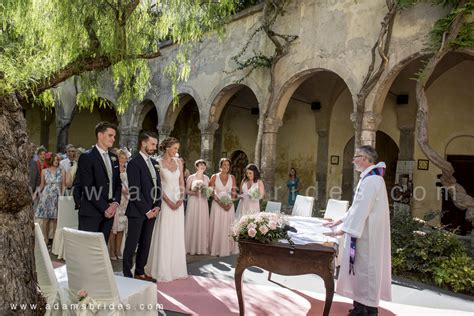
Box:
0 96 45 315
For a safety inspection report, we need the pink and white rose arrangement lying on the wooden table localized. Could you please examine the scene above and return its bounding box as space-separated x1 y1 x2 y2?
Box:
232 212 289 243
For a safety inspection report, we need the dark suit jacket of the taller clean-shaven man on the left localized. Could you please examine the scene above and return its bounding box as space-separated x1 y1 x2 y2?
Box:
76 146 122 217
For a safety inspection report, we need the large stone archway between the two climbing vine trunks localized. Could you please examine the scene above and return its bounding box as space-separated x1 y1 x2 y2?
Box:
270 69 353 210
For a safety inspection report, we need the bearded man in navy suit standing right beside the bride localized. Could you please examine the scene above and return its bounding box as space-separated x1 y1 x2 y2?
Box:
123 132 161 280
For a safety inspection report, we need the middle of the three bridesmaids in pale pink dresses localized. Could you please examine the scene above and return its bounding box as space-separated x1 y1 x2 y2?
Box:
209 158 238 257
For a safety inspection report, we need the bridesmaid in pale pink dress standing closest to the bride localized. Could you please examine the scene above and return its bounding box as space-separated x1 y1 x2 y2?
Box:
185 159 209 255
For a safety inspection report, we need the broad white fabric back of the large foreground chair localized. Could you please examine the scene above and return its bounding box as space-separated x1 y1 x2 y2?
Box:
63 228 120 303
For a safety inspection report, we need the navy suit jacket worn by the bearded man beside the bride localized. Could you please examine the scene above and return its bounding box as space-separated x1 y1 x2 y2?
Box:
125 154 161 217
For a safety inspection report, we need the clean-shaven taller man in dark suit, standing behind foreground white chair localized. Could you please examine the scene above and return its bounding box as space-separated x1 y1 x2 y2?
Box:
76 122 122 242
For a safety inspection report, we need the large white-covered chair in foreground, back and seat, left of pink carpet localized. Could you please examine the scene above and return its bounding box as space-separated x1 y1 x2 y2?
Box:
63 228 157 315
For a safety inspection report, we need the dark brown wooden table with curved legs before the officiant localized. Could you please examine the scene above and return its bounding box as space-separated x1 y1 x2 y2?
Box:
234 240 337 316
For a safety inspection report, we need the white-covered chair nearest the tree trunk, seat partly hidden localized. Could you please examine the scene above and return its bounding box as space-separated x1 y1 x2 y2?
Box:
35 224 67 315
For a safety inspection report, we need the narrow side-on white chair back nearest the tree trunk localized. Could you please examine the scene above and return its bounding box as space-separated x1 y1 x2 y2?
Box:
35 223 59 303
